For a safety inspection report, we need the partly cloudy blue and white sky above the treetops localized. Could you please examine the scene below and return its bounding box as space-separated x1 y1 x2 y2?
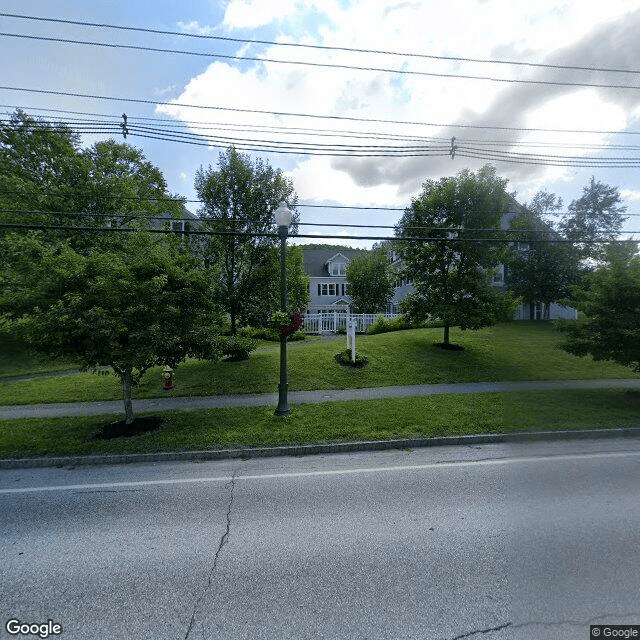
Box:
0 0 640 246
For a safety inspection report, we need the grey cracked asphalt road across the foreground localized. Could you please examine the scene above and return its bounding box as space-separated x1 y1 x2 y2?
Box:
0 439 640 640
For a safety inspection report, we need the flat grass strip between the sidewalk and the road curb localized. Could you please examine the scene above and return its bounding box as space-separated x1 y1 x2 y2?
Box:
0 390 640 457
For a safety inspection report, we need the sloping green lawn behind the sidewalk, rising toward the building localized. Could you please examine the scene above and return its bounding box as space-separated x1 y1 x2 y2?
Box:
0 322 638 405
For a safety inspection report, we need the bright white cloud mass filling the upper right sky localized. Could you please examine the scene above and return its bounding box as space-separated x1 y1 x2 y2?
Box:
160 0 640 222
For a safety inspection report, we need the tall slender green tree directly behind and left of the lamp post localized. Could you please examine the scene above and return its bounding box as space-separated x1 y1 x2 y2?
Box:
195 147 298 335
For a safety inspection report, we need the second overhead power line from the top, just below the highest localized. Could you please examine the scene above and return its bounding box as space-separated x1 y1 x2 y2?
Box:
6 32 640 90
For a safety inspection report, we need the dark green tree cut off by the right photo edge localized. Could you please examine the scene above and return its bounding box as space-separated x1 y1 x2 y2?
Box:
561 245 640 372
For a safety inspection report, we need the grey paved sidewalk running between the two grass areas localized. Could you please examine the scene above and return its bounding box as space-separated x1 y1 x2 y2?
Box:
0 378 640 420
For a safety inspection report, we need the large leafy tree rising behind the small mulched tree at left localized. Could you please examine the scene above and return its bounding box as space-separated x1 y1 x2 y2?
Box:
0 111 183 253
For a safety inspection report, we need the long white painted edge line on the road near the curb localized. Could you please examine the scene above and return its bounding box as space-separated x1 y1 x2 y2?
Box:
0 451 640 495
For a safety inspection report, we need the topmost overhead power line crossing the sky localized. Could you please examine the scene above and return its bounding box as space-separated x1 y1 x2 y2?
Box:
5 13 640 74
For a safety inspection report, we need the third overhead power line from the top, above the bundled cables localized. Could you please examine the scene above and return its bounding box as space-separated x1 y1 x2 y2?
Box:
0 85 640 136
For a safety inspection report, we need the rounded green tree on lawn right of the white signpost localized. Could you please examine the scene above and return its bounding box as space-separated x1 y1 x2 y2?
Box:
396 165 515 346
